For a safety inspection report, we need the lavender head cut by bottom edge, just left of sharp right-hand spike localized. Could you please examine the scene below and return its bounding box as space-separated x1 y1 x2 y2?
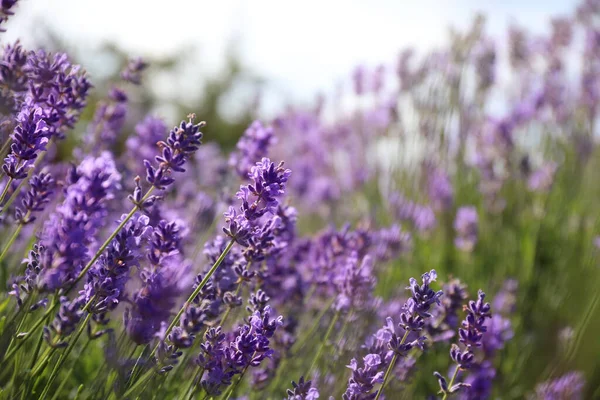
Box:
342 354 383 400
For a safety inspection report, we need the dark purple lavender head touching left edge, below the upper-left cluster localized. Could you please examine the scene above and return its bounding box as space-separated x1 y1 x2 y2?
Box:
2 103 48 180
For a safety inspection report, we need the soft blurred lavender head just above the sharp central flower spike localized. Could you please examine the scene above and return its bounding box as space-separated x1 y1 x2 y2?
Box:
229 121 276 179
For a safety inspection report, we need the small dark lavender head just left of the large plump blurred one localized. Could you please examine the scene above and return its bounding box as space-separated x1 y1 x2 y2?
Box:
15 172 55 225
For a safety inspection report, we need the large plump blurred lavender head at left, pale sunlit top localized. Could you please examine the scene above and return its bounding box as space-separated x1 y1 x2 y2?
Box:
40 153 121 291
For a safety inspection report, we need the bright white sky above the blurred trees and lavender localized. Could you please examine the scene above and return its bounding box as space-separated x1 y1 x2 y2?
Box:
5 0 577 115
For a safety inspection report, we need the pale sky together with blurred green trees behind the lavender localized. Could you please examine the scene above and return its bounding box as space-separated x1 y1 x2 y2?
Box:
5 0 575 146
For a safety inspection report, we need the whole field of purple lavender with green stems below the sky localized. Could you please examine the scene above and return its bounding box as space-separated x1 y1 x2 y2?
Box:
0 0 600 400
